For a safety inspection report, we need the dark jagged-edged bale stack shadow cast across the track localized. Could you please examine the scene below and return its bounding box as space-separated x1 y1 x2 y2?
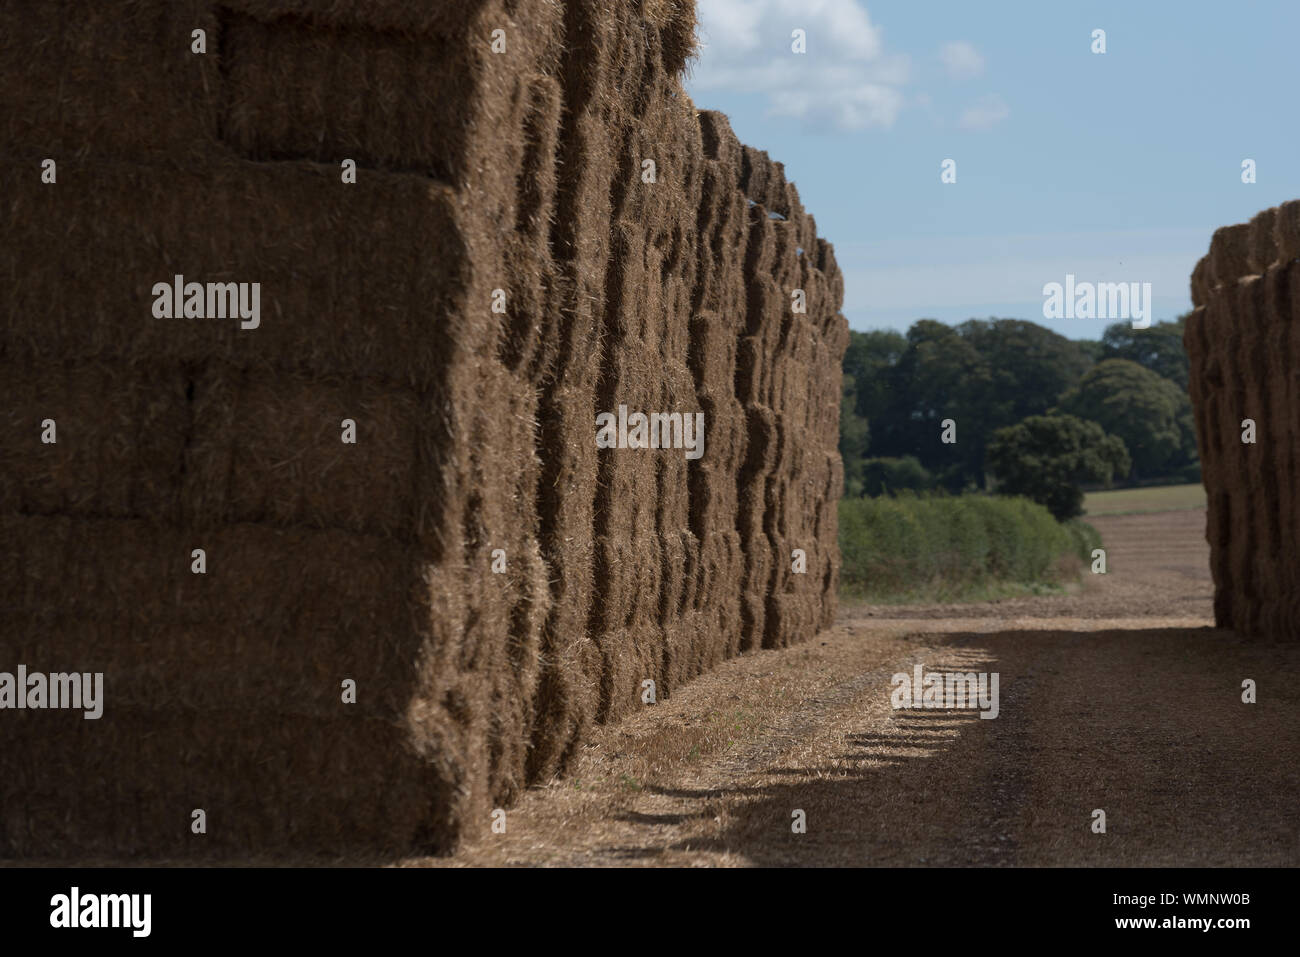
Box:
621 628 1300 866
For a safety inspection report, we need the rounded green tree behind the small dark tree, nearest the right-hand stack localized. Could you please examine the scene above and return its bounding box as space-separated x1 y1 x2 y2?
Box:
1060 359 1195 479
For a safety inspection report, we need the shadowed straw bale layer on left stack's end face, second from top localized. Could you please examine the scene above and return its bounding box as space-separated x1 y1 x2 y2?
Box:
0 161 478 387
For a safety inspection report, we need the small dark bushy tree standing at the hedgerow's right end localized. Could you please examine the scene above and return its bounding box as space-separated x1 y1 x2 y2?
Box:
988 415 1130 521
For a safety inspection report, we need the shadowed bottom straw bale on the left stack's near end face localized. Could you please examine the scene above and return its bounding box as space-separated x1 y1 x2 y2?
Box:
0 701 458 863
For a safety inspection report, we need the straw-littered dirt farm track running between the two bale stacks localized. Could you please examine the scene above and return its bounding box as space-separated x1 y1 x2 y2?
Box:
421 510 1300 866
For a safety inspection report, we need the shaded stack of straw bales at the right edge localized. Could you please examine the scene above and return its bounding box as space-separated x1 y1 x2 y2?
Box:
1183 200 1300 637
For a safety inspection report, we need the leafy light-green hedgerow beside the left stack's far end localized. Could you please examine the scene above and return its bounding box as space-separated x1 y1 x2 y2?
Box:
840 493 1101 601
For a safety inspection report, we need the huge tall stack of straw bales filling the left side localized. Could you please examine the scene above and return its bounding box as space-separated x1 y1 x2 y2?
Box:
0 0 848 857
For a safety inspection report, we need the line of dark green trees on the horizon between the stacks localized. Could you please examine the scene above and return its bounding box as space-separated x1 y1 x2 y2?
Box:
840 316 1200 519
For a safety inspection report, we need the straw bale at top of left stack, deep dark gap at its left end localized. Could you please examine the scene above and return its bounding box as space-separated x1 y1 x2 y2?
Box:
221 0 560 187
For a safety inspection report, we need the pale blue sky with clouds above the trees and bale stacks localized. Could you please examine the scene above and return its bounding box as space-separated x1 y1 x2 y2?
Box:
686 0 1300 338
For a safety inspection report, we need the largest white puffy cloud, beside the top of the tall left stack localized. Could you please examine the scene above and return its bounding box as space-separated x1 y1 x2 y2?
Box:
690 0 910 130
